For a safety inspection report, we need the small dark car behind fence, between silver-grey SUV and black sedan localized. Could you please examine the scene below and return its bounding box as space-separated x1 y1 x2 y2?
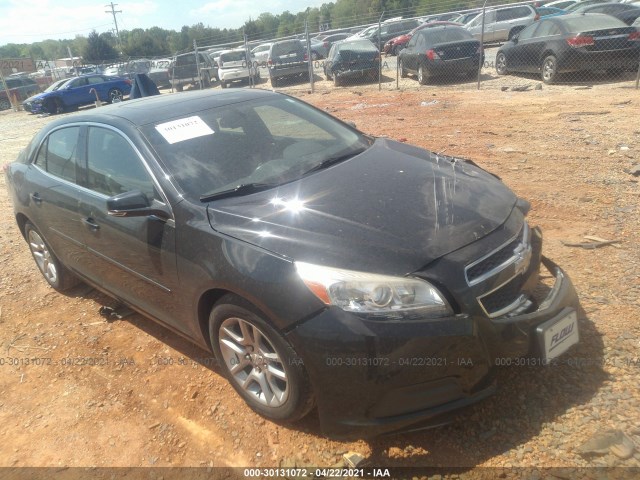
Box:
324 39 380 87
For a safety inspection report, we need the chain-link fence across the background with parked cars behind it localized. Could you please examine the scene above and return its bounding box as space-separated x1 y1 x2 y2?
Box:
3 0 640 112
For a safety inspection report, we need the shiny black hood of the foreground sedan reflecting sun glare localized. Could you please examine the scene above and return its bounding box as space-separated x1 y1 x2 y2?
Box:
207 139 517 275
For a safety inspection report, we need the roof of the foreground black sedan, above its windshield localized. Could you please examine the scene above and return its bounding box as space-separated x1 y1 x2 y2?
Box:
48 88 281 126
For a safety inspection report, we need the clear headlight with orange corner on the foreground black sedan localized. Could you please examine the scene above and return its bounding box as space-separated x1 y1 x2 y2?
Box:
295 262 453 318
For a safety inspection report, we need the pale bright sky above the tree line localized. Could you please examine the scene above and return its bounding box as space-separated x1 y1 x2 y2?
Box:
0 0 329 45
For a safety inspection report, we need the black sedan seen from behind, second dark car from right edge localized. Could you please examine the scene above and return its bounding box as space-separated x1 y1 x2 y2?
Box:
398 26 482 85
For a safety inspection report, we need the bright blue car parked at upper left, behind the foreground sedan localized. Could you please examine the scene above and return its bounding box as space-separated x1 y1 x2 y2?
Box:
22 74 131 115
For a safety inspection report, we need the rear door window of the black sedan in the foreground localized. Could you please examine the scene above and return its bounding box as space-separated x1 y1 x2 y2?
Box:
34 127 80 183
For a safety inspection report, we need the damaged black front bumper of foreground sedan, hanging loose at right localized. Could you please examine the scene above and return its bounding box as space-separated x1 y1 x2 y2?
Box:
288 258 578 438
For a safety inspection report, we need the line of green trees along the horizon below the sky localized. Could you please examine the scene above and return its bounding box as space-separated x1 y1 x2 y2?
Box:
0 0 480 63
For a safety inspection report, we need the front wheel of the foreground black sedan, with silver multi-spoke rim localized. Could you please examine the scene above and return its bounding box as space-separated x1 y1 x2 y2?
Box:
209 294 315 422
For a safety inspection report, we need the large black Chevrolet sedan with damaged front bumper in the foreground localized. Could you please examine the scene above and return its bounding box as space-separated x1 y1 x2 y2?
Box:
6 89 579 437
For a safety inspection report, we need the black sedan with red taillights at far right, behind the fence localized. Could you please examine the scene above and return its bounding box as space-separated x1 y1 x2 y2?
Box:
496 13 640 83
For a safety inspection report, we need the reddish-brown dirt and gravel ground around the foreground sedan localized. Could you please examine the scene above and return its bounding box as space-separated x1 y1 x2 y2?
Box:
0 78 640 477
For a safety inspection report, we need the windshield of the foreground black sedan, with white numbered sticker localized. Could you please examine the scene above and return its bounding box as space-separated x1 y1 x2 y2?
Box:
141 96 372 202
